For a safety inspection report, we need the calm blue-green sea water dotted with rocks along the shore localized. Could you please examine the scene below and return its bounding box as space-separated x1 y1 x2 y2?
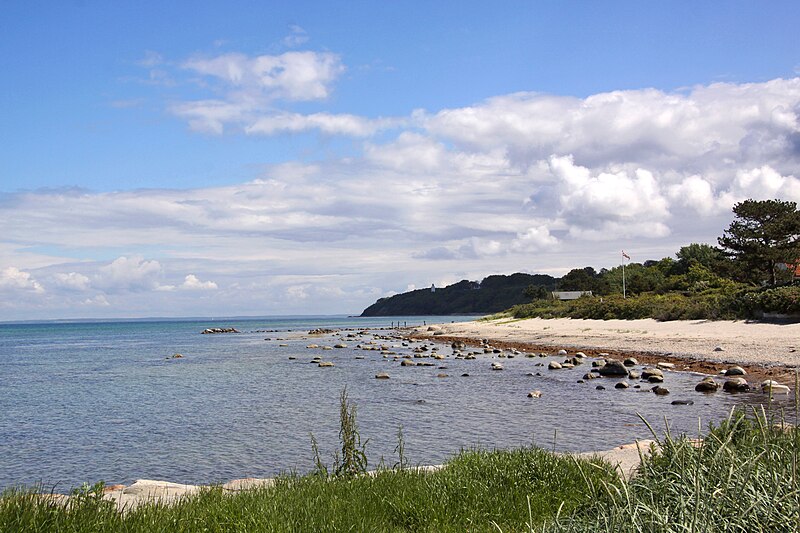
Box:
0 317 789 490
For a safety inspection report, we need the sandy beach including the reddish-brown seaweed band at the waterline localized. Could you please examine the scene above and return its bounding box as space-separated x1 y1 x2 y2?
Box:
413 318 800 384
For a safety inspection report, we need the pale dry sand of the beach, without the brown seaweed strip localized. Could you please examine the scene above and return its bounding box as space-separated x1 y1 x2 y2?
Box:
418 318 800 366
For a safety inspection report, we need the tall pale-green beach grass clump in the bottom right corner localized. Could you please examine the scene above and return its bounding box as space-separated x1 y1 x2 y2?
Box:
548 411 800 532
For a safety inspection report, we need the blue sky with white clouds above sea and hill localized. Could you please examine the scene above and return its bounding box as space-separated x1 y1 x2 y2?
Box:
0 0 800 321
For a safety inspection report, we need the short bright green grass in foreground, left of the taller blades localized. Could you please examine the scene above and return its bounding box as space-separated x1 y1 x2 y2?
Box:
0 448 619 532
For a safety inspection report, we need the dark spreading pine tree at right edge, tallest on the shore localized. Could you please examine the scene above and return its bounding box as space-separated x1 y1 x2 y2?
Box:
717 200 800 286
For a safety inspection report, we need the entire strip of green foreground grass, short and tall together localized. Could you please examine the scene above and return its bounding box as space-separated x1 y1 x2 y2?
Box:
0 410 800 532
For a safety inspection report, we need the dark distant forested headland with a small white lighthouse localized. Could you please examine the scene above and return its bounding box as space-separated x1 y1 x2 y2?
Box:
361 273 556 316
